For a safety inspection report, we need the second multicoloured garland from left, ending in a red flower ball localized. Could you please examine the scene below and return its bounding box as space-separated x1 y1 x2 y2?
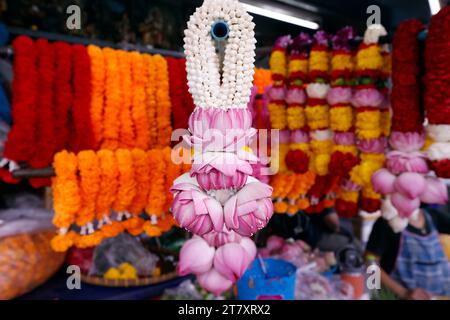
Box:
285 33 311 174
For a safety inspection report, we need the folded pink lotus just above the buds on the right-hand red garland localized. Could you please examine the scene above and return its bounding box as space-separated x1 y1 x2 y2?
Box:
386 151 428 175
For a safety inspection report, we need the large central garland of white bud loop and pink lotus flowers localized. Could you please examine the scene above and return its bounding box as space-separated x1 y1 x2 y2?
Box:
171 0 276 295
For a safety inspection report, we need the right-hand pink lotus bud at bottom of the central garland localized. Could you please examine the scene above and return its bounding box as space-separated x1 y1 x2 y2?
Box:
214 238 256 282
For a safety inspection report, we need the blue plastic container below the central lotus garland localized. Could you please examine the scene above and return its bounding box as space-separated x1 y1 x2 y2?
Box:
237 258 296 300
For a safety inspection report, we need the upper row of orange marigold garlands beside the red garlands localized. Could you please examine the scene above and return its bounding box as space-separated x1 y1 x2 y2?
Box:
88 46 172 150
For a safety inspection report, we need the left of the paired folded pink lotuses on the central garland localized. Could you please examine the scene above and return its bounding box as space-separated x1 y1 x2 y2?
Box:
170 173 223 235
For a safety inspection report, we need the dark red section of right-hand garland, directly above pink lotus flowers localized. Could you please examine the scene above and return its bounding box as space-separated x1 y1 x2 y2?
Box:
391 20 424 132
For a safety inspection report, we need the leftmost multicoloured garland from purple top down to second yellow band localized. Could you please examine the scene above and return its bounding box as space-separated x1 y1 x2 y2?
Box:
267 36 291 130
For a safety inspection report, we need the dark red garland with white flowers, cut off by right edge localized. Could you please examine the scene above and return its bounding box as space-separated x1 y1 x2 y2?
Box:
424 6 450 179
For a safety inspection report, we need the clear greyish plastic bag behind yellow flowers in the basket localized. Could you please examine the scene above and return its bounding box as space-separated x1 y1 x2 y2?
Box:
89 233 159 277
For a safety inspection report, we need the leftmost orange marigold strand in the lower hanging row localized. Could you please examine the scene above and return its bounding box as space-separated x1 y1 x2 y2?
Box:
51 151 81 251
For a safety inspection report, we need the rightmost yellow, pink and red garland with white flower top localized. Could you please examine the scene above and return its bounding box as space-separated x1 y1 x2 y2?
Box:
350 25 387 212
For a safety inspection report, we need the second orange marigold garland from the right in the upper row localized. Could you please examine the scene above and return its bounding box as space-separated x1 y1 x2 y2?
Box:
131 52 151 150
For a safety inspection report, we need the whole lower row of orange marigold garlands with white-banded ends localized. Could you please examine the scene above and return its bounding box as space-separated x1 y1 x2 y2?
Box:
52 147 190 251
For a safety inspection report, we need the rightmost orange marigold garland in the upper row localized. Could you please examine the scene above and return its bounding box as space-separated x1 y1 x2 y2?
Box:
153 55 172 148
